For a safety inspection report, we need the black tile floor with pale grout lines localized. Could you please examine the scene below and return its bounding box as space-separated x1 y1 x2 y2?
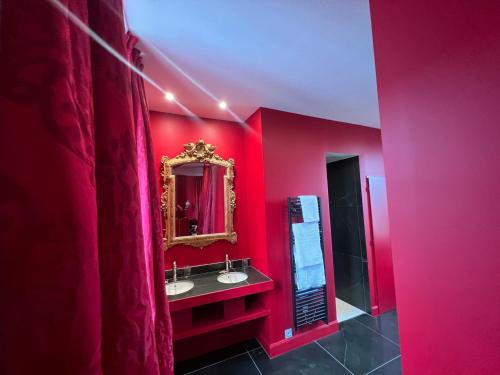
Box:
175 311 402 375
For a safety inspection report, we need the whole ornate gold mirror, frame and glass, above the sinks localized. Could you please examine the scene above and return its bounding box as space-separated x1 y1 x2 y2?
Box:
161 139 236 250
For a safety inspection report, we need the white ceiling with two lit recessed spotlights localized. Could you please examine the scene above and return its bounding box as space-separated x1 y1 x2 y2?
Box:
124 0 379 127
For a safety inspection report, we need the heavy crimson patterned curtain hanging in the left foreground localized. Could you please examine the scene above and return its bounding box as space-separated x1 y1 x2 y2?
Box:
0 0 173 374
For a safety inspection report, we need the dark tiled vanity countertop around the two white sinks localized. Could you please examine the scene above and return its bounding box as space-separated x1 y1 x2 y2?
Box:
167 267 271 302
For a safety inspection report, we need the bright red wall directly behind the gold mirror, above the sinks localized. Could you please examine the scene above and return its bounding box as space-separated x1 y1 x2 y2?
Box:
150 112 251 268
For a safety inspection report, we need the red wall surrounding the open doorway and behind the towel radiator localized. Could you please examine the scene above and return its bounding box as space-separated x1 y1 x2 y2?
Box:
258 109 384 351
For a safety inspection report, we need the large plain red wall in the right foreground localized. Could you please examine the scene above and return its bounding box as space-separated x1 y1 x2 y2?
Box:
371 0 500 375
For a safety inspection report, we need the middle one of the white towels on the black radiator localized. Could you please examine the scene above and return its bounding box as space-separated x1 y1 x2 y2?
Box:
292 223 323 269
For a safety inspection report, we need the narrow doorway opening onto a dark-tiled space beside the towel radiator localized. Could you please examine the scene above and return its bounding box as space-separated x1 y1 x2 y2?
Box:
326 154 370 322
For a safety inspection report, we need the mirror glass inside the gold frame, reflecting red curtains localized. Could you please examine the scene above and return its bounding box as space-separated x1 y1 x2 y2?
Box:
172 163 226 237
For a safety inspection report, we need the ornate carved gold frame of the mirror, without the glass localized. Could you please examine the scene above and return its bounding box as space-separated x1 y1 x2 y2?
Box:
161 139 237 250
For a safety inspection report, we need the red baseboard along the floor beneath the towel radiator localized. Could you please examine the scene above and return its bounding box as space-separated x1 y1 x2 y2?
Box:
258 320 339 358
